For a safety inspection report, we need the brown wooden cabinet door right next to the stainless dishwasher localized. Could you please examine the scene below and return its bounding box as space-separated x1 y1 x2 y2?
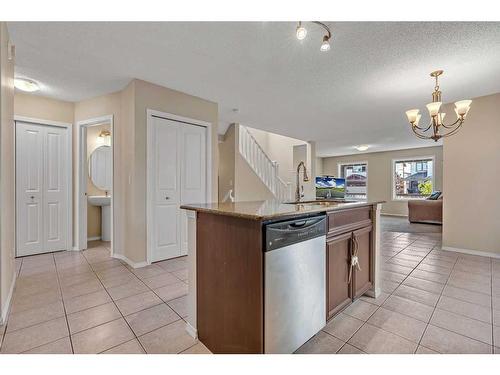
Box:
326 232 352 318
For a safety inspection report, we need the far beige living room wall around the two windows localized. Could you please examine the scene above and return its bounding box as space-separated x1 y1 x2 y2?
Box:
323 148 447 215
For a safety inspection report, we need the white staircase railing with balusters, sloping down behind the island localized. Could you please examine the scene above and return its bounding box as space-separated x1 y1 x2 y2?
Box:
239 125 292 201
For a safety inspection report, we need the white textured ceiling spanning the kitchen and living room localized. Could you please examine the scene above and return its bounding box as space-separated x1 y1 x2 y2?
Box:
8 22 500 156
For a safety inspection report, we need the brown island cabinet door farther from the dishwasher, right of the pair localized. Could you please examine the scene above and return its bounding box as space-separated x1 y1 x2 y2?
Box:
352 226 373 298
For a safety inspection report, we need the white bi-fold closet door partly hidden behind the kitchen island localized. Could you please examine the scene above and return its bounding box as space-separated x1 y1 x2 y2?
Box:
148 116 207 262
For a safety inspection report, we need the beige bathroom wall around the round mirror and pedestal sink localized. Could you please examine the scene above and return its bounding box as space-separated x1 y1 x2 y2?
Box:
87 124 111 238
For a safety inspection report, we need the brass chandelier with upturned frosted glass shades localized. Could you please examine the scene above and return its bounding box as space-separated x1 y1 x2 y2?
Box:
406 70 472 142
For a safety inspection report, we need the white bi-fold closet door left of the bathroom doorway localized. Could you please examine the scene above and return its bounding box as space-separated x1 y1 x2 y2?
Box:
16 122 71 256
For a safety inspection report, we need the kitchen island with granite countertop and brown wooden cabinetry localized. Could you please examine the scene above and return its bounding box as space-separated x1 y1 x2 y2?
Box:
181 201 383 353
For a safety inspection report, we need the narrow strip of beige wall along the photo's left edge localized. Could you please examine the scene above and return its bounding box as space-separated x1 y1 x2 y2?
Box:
0 22 16 323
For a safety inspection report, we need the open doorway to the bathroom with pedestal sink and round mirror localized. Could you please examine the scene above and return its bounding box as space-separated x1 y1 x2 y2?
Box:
75 115 114 255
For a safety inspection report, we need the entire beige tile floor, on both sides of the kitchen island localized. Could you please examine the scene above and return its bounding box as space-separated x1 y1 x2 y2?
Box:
0 232 500 354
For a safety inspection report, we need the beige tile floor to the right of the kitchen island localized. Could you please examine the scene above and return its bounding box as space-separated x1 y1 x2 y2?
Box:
297 232 500 354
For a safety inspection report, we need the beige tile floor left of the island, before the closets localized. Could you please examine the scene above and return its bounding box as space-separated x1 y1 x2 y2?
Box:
0 242 208 354
